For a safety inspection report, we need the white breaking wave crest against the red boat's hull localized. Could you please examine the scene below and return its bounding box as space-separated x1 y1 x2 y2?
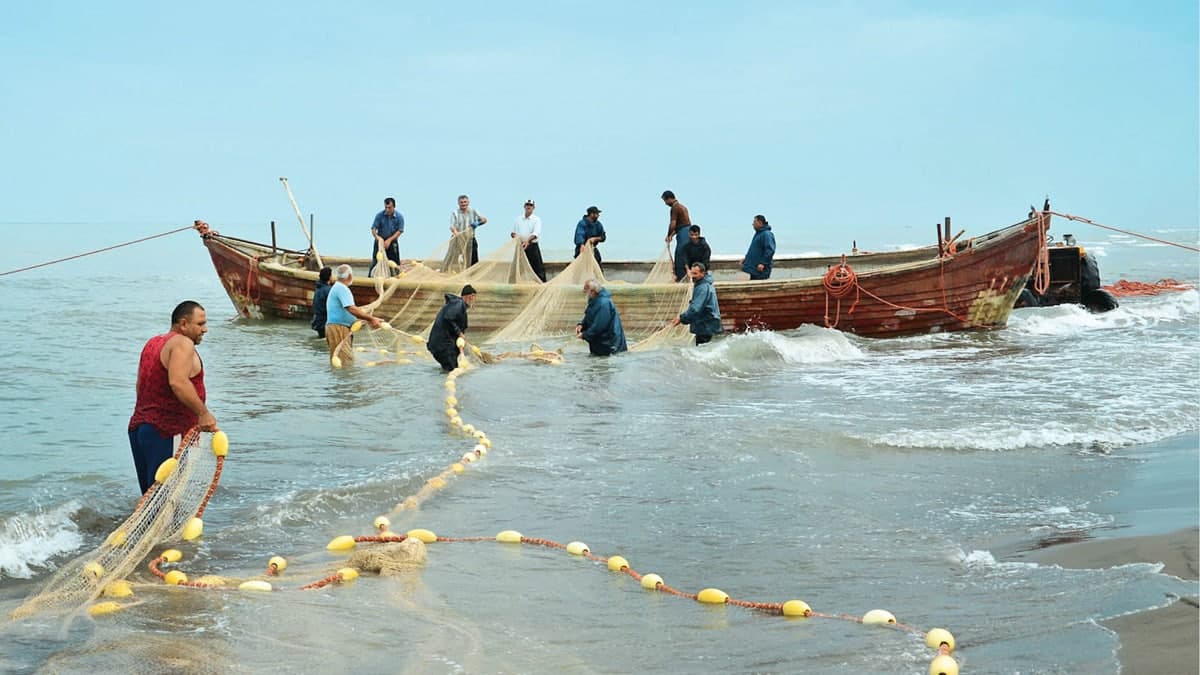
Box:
684 325 865 374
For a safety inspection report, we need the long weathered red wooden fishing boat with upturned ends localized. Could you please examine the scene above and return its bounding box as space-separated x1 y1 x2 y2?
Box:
197 214 1049 339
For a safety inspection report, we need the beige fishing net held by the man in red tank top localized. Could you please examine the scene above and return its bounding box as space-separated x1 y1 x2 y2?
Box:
12 430 228 619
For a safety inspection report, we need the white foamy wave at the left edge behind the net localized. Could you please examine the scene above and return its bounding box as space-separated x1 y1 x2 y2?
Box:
0 502 83 579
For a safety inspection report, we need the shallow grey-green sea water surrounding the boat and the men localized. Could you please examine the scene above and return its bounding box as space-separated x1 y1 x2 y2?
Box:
0 223 1200 673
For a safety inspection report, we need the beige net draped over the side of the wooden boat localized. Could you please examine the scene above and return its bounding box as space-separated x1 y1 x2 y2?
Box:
337 231 691 365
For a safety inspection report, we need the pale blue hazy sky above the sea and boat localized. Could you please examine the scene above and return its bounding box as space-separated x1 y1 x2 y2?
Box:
0 0 1200 265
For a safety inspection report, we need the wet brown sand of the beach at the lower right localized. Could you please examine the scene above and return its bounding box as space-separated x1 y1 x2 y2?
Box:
1034 527 1200 674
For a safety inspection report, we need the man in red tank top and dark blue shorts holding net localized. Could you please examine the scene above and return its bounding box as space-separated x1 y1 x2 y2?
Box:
128 300 217 494
